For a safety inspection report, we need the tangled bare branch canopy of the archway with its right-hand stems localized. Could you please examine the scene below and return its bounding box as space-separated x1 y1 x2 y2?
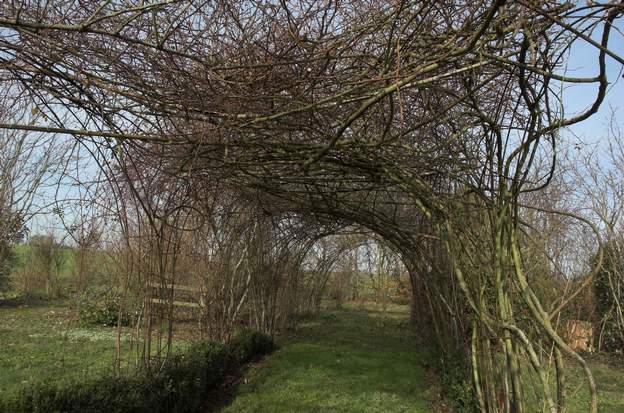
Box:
0 1 624 413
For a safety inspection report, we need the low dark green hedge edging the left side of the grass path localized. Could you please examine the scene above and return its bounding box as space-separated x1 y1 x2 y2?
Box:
0 331 273 413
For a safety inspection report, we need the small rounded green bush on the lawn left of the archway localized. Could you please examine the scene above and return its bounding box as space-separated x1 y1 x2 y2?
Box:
77 288 132 327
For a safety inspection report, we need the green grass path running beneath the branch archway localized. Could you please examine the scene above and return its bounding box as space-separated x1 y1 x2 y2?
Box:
222 307 436 413
